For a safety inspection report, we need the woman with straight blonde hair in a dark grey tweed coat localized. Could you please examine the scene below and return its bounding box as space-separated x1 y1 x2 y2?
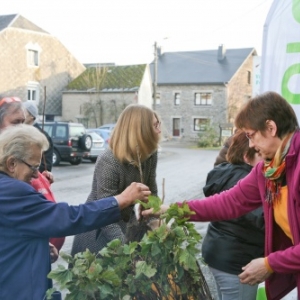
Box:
71 104 160 255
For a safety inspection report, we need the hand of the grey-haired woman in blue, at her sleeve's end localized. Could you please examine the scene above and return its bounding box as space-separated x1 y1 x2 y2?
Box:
115 182 151 209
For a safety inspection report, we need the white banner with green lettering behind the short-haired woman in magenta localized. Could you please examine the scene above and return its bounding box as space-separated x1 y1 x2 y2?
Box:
260 0 300 120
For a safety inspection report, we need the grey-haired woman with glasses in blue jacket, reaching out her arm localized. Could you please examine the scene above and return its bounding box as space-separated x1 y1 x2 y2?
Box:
0 124 151 300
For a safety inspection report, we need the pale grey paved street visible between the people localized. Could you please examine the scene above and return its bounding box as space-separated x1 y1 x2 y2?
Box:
52 142 297 300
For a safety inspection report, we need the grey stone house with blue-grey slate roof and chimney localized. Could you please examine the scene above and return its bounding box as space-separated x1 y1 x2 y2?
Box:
150 45 256 141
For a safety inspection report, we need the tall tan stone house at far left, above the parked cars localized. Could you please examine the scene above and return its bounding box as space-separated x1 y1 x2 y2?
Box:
0 14 85 120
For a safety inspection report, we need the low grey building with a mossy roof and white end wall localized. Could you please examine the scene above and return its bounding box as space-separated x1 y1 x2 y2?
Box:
62 64 152 128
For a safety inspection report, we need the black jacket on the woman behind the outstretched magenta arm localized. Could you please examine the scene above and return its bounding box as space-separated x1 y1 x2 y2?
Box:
202 162 264 275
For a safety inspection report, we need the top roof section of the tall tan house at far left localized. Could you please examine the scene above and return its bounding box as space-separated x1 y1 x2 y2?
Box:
0 14 48 33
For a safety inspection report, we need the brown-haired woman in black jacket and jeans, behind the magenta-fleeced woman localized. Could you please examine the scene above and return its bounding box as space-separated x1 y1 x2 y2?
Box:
202 130 264 300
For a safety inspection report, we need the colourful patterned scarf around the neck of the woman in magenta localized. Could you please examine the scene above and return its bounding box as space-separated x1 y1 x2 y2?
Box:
263 132 294 204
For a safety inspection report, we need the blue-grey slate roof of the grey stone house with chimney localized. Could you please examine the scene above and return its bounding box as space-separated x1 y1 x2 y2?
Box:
150 48 256 85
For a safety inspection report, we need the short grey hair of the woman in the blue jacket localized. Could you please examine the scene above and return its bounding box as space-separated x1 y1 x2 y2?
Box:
0 124 49 167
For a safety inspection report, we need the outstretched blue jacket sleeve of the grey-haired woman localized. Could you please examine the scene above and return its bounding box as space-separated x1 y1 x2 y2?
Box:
0 178 120 237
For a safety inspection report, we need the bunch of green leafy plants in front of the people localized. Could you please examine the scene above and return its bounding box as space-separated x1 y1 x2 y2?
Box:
47 196 211 300
